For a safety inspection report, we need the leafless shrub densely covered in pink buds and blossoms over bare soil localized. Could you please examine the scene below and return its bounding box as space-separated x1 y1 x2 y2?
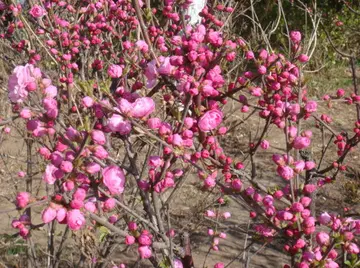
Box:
1 0 360 267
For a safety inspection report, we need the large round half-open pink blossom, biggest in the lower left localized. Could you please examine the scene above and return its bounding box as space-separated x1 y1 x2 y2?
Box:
102 166 125 194
